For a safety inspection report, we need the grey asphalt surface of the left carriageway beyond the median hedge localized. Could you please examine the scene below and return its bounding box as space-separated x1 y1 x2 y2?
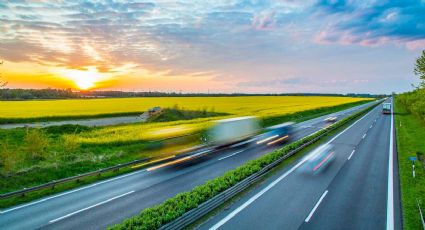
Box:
0 101 374 229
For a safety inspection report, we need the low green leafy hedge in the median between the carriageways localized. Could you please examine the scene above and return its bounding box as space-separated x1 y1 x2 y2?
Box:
110 103 374 230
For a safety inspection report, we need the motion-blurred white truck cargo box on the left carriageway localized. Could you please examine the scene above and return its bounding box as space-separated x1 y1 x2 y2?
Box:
208 117 260 147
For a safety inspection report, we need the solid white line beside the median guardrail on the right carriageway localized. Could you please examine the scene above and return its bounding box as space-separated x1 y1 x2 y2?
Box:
210 109 375 230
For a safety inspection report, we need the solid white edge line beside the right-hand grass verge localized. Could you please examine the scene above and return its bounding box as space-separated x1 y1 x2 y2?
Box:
387 101 394 230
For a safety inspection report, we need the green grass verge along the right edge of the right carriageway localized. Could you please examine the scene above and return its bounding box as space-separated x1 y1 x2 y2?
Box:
394 98 425 230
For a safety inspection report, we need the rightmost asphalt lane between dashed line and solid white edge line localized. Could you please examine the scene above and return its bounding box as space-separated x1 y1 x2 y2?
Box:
300 104 391 229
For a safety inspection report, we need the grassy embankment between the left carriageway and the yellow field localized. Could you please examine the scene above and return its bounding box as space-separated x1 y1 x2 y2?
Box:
0 96 370 207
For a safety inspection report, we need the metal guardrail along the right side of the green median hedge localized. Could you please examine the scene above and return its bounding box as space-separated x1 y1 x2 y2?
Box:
160 103 379 230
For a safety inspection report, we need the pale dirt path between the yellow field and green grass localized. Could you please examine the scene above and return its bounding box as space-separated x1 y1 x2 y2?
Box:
0 115 148 129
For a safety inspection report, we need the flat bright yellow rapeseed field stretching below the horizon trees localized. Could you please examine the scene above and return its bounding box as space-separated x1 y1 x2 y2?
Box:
0 96 364 119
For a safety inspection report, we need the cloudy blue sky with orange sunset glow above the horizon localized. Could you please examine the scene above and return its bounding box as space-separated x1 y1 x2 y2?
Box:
0 0 425 93
